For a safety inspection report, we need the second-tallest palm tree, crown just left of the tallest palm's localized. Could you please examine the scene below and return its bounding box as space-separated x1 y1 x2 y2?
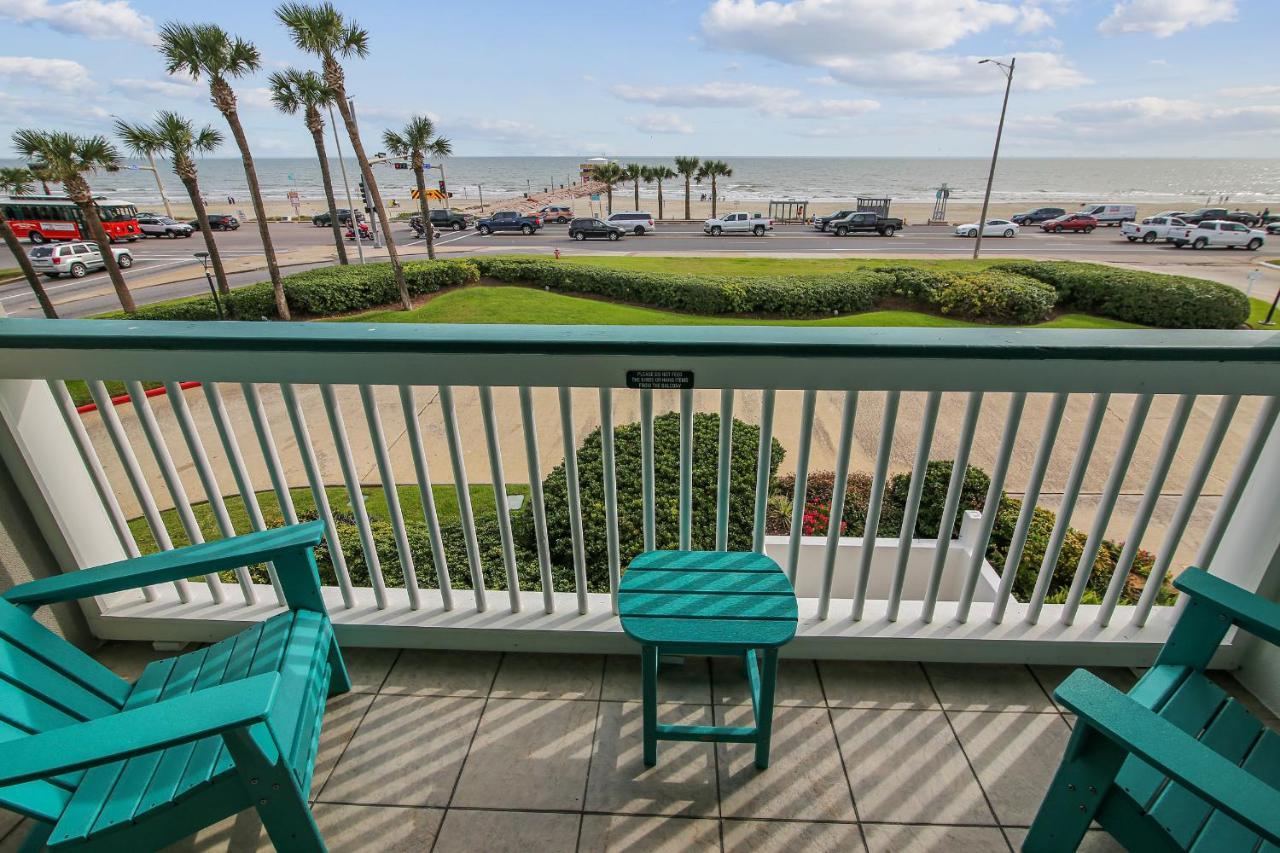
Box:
159 23 289 320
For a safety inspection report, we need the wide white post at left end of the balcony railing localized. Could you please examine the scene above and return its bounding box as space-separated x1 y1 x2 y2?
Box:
0 379 128 604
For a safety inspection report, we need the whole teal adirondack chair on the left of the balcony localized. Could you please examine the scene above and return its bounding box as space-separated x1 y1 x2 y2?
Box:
0 521 351 850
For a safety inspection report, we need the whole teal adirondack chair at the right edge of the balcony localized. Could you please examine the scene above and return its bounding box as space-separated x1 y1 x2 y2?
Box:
1023 569 1280 853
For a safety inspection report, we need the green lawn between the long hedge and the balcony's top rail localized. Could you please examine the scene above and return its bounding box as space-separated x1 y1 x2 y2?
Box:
339 281 1143 329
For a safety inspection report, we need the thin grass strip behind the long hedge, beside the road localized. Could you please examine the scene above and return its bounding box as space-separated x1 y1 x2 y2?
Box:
563 253 1003 275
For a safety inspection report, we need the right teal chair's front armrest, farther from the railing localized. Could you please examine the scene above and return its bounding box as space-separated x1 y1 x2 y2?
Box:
1053 670 1280 843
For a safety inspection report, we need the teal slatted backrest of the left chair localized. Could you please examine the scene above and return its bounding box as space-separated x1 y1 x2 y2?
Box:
0 599 129 821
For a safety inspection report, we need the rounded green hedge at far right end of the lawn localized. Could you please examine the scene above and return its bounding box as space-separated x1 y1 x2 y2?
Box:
991 261 1249 329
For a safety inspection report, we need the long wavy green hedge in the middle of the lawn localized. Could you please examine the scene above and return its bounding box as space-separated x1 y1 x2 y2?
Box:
472 257 1053 323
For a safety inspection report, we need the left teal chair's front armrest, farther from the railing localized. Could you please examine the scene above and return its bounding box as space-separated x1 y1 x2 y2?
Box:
0 672 280 786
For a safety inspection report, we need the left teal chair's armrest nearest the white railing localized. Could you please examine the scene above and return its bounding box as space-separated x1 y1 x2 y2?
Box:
4 521 324 607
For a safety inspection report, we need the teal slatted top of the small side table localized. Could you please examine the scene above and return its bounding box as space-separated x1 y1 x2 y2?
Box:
618 551 797 648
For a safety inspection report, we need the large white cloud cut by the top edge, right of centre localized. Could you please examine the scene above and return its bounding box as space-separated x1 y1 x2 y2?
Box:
701 0 1088 95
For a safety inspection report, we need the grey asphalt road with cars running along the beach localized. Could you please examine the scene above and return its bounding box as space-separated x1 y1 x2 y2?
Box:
0 223 1280 316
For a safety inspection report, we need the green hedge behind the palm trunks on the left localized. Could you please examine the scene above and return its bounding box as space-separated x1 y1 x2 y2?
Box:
108 260 480 320
